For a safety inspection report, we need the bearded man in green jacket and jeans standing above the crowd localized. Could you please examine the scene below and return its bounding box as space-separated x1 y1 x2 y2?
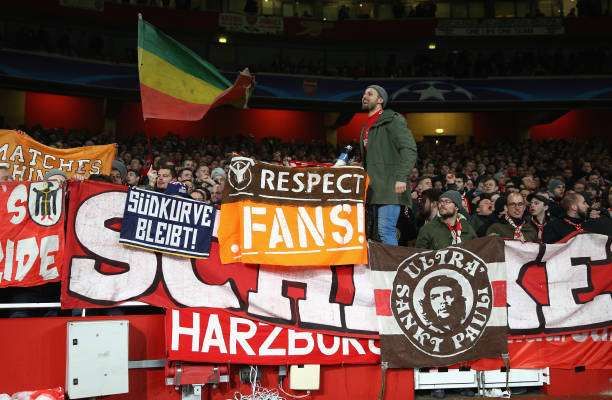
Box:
360 85 417 246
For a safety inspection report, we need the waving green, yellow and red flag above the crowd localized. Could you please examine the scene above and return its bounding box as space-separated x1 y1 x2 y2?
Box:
138 17 254 121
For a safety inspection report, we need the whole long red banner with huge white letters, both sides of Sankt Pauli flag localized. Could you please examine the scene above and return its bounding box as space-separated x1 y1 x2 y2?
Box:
62 181 612 338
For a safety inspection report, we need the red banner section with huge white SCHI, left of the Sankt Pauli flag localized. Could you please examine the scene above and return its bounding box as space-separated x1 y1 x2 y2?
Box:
61 181 378 337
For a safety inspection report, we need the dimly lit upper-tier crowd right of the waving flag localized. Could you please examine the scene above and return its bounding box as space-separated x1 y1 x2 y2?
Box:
260 46 612 78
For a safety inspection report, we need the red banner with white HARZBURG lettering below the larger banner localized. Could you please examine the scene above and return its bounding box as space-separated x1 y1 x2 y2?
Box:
166 309 380 365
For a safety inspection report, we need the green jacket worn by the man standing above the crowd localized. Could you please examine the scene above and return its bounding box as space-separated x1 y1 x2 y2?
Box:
359 110 417 206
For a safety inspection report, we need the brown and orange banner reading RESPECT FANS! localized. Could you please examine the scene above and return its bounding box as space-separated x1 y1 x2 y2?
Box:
219 157 367 266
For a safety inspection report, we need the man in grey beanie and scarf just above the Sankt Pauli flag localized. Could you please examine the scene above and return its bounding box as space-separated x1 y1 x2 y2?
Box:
415 190 476 250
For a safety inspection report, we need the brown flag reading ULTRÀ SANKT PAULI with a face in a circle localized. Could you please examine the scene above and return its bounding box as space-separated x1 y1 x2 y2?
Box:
369 237 508 368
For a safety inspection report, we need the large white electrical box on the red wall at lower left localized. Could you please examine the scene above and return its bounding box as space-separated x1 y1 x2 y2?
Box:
66 320 129 399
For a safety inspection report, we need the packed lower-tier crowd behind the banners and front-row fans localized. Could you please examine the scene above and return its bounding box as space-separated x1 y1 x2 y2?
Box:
17 128 612 244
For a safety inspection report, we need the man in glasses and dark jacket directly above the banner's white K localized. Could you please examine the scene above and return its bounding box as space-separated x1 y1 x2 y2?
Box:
487 192 538 242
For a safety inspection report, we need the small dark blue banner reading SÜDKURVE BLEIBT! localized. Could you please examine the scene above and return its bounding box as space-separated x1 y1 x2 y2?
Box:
119 188 216 257
